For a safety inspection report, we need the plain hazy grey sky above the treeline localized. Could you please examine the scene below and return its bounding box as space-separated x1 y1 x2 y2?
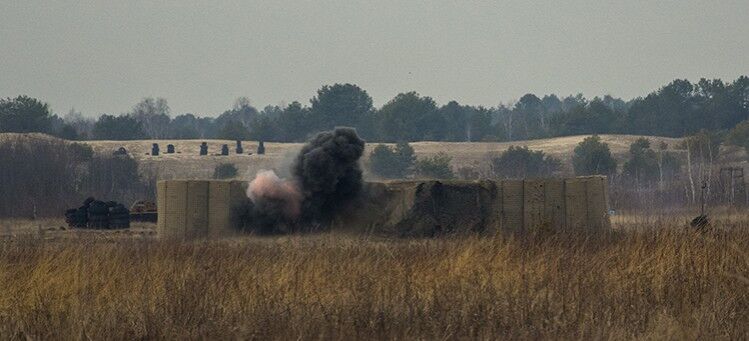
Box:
0 0 749 115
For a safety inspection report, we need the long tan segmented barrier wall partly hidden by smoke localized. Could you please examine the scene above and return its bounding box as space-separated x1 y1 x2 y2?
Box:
157 176 610 238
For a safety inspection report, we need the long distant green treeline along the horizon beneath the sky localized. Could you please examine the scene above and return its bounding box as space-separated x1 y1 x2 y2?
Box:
0 76 749 142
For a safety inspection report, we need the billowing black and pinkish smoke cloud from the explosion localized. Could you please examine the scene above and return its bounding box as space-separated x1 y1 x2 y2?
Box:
244 128 364 232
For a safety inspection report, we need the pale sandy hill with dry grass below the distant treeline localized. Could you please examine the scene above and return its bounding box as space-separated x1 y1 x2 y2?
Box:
0 134 681 179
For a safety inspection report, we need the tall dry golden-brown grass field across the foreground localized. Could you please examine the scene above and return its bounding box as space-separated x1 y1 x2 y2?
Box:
0 225 749 340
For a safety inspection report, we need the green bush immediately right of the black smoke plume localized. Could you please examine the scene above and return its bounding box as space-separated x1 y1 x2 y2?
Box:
369 142 416 179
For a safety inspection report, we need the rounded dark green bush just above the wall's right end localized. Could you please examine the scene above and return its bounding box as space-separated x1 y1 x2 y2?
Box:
572 135 616 175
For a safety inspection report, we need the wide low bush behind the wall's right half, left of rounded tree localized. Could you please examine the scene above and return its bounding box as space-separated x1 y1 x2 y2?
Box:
492 146 561 179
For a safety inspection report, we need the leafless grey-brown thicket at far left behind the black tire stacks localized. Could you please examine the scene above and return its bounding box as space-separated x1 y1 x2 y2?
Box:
0 135 155 218
